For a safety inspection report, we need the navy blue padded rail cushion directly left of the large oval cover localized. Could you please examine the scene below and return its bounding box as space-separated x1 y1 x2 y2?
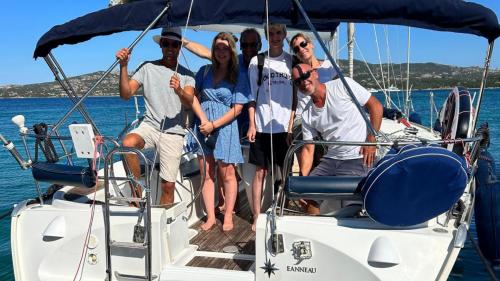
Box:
285 176 363 200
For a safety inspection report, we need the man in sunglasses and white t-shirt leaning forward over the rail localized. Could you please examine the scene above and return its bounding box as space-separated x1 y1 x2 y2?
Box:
292 64 383 213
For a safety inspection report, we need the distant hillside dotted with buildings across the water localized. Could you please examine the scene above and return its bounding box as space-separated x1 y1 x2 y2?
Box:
0 60 500 98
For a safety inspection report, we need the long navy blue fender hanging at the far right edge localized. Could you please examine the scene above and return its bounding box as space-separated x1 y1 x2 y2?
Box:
474 149 500 264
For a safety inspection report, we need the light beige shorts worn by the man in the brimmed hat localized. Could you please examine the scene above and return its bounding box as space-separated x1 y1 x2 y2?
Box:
130 122 184 182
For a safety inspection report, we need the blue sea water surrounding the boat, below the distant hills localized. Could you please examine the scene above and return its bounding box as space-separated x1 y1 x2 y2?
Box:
0 90 500 281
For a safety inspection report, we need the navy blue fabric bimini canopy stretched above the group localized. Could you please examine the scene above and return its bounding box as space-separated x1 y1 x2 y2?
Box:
34 0 500 58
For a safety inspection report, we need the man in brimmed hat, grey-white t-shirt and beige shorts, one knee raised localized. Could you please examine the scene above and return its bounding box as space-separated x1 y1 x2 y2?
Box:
116 27 195 204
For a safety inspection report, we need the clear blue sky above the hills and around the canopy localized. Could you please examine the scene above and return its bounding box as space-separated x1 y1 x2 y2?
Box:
0 0 500 85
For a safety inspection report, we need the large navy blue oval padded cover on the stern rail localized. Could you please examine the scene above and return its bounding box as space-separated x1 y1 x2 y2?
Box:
360 145 468 226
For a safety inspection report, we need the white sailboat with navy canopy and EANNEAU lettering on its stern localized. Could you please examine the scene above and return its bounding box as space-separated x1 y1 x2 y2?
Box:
2 0 500 281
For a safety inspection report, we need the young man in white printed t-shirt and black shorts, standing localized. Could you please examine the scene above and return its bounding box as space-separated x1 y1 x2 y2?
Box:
247 24 296 230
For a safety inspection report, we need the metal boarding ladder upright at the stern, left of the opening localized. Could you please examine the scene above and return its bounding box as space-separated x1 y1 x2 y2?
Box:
104 147 157 281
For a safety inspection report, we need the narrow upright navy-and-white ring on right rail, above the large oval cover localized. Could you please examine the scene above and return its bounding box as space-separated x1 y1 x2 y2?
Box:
439 87 472 155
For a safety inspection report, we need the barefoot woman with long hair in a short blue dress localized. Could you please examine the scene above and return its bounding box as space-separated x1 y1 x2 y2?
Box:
193 32 250 231
